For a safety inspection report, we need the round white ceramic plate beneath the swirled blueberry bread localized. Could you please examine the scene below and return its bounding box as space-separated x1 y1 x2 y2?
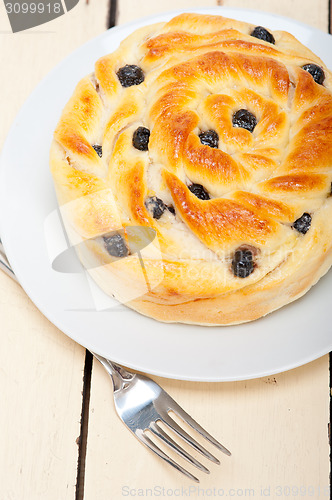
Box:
0 7 332 381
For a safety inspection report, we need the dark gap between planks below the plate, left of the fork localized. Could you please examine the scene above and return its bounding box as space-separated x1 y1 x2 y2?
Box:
75 349 93 500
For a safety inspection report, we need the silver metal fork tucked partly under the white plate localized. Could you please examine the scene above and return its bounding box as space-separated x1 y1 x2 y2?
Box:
0 240 231 483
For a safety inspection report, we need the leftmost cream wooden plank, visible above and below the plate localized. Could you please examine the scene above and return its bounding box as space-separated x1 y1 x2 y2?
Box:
0 0 108 500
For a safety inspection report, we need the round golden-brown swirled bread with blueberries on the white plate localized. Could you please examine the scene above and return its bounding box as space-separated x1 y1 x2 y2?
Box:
51 14 332 325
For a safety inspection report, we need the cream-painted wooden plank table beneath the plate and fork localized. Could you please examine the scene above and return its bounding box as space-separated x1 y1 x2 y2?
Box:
0 0 330 500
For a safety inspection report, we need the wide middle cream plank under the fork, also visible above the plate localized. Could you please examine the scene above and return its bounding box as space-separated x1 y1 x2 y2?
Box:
84 0 329 500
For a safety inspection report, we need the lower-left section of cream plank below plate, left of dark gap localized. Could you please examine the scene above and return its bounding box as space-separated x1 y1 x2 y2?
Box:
0 273 84 500
